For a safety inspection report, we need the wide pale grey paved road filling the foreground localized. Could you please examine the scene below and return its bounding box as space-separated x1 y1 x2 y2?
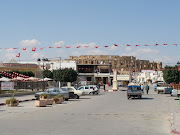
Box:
0 86 179 135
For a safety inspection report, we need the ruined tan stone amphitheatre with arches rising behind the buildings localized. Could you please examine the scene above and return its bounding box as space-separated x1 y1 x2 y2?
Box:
69 55 162 71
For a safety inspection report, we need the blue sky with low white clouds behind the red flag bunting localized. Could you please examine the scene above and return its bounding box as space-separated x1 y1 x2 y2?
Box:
0 0 180 65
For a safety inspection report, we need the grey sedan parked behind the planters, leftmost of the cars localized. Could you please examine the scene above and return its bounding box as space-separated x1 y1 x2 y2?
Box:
35 87 69 101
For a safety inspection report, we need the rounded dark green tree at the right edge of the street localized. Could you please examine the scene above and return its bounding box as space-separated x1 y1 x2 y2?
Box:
163 65 179 83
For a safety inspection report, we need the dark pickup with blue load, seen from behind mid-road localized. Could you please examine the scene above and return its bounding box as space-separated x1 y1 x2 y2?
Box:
127 85 142 99
